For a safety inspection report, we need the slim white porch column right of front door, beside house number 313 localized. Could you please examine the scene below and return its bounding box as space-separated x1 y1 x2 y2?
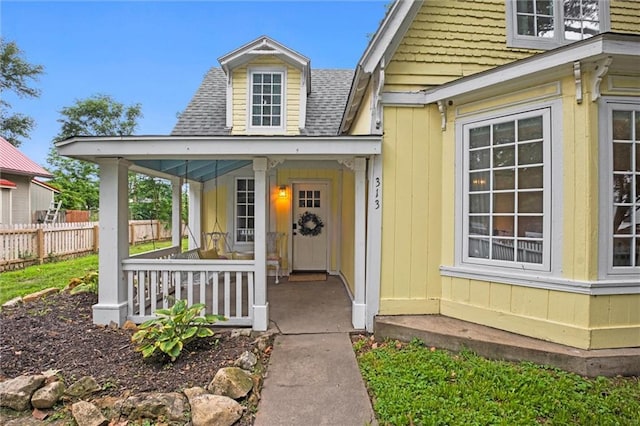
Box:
351 157 367 329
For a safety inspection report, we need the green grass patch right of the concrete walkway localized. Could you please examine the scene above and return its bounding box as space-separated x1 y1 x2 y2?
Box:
354 338 640 425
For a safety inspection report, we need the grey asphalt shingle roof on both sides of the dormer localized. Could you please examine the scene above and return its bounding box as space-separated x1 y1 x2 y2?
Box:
171 67 353 136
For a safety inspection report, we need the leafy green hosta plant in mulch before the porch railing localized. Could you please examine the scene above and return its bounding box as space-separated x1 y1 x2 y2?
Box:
131 300 226 362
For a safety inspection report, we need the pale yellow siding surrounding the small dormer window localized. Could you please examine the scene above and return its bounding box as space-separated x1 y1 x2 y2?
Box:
232 56 302 135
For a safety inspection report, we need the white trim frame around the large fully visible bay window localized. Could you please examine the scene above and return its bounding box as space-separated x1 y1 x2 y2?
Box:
448 99 565 285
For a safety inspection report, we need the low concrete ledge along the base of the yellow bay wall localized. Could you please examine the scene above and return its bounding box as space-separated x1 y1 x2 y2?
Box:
375 315 640 377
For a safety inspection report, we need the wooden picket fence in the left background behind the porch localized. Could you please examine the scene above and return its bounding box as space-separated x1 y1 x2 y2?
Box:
0 220 171 272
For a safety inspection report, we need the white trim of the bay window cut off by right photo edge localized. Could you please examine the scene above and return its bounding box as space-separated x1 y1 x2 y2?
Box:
598 97 640 282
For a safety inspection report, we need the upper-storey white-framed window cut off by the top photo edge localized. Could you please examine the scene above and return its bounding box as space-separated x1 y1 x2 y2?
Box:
506 0 609 49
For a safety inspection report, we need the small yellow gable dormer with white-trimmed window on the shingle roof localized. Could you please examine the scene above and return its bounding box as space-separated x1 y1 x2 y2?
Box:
218 36 311 135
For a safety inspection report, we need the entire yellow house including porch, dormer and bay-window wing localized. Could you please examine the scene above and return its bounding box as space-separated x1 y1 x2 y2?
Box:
58 0 640 349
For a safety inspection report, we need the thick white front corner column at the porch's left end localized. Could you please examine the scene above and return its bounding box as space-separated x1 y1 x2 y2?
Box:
93 158 129 326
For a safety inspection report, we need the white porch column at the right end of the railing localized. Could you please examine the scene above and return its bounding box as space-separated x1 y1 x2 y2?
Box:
253 158 269 331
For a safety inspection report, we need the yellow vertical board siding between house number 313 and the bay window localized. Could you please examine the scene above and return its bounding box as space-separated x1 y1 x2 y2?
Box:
381 107 441 314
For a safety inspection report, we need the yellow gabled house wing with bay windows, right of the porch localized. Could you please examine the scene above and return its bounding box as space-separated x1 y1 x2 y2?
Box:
341 0 640 349
